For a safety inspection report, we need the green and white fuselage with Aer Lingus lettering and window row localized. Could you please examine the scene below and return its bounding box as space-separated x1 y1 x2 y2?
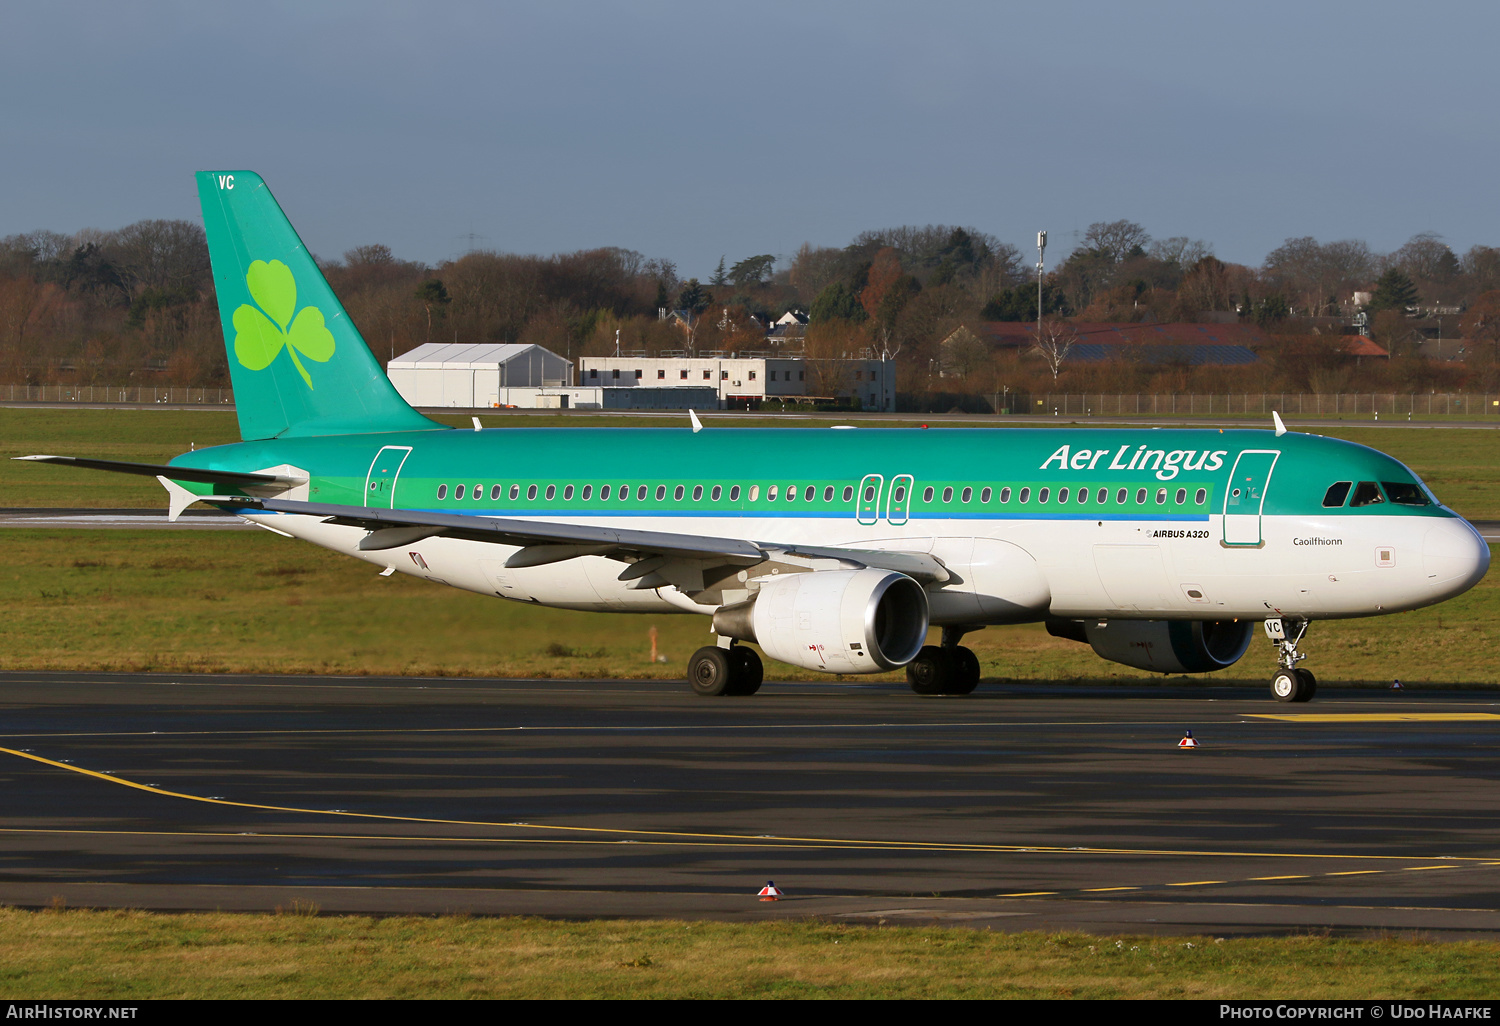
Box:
174 426 1487 626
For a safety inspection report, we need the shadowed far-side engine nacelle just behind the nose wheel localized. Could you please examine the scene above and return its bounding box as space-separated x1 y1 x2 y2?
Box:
1047 620 1256 674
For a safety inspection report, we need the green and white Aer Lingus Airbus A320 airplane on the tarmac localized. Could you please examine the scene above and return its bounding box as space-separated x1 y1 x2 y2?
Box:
17 171 1490 702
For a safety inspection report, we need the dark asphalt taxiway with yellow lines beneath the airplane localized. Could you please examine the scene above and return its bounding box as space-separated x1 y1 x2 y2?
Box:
0 674 1500 938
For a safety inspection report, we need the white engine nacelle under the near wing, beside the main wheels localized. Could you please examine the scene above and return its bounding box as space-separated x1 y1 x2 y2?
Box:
714 570 927 674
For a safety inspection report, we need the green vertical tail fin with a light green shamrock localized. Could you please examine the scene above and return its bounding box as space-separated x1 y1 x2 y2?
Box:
198 171 443 440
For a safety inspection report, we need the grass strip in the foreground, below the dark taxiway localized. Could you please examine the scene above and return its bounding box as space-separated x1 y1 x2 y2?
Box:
0 909 1500 1001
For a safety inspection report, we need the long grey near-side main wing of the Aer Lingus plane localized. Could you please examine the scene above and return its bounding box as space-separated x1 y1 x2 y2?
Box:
228 497 950 584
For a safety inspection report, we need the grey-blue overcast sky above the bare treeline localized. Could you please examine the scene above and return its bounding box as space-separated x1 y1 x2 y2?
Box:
0 0 1500 278
